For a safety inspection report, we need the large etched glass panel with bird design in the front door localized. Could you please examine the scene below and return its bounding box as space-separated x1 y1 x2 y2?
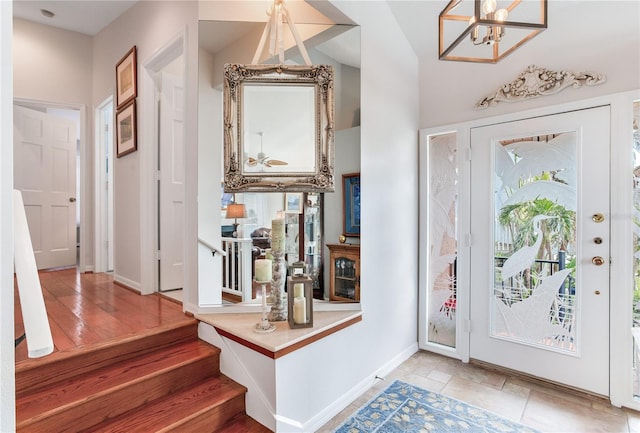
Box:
491 133 577 352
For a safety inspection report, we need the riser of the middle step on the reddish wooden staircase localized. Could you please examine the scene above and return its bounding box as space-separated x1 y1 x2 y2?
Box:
17 344 219 433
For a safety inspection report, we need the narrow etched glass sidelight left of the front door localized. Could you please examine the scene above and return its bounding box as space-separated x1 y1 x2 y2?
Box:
427 132 459 347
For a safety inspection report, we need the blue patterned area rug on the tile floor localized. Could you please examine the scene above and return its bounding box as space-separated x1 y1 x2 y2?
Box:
334 380 537 433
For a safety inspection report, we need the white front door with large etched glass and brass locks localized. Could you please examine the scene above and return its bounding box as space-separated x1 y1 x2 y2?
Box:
470 106 610 395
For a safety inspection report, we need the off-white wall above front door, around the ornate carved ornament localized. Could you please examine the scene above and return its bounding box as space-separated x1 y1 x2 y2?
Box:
420 0 640 128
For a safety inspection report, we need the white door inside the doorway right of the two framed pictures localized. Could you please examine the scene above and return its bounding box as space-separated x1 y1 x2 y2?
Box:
159 72 184 291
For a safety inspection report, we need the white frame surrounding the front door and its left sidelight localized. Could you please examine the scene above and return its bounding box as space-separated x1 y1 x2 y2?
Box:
418 89 640 410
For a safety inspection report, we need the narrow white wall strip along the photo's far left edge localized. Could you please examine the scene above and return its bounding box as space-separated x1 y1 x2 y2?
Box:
0 1 15 432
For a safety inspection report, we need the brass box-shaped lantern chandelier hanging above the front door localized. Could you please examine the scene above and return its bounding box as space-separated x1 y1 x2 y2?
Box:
438 0 547 63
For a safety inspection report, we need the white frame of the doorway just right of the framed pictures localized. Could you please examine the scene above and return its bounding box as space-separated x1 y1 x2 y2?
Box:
138 30 188 295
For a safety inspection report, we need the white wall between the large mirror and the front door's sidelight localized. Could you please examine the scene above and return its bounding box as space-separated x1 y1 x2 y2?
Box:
201 1 418 431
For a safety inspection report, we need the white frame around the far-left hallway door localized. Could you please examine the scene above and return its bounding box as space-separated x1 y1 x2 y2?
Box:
13 98 93 273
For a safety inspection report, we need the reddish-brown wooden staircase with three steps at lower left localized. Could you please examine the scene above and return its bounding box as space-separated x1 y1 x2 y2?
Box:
16 320 270 433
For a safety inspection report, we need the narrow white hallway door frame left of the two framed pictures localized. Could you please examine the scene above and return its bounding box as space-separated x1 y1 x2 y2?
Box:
93 95 115 272
